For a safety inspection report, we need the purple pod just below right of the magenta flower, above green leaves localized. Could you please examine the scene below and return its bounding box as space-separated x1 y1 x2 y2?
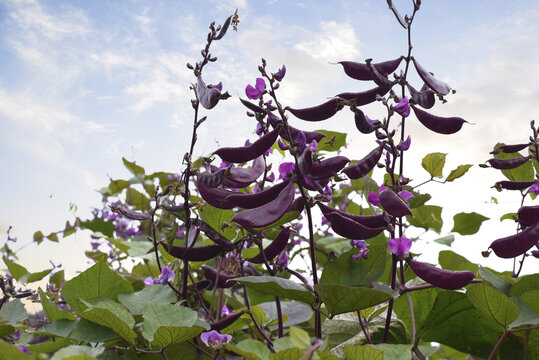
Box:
408 260 475 290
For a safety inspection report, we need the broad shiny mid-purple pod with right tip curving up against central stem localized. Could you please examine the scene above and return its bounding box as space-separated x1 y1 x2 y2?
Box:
232 181 294 228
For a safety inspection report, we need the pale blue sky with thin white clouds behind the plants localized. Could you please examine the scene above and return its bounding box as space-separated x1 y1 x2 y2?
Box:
0 0 539 278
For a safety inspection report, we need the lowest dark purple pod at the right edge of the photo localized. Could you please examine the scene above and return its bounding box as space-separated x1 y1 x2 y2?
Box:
489 223 539 259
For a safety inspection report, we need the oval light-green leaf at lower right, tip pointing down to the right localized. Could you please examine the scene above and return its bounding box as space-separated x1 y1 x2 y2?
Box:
466 283 519 329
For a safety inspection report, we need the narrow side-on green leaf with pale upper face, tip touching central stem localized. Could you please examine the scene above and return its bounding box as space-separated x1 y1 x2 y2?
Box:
235 276 315 305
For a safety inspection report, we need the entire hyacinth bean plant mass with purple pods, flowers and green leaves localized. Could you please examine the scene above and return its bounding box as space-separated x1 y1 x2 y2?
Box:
0 0 539 360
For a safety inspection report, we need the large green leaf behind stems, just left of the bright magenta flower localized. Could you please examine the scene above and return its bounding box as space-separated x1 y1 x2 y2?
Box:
320 245 387 285
